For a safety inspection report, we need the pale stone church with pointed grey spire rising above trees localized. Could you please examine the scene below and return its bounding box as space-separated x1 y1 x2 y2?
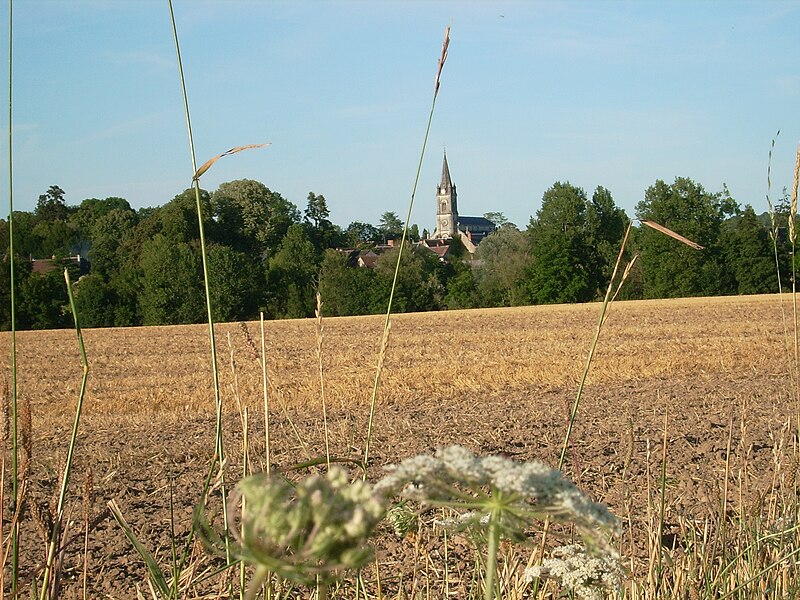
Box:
422 153 496 254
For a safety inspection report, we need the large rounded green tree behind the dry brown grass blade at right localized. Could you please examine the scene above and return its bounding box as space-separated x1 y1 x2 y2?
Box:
636 177 736 298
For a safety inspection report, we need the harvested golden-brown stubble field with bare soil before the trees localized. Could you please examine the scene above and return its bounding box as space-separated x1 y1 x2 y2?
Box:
2 296 797 598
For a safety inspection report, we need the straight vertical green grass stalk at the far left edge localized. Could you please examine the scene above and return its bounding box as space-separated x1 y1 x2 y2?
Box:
3 0 21 598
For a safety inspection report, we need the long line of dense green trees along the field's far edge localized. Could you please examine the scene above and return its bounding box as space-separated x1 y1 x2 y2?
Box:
0 178 790 329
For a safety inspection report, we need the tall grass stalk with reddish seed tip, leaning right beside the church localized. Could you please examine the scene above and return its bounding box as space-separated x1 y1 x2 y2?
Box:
364 27 450 466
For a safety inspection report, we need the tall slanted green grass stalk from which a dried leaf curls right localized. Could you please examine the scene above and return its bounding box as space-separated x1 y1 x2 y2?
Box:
167 0 231 564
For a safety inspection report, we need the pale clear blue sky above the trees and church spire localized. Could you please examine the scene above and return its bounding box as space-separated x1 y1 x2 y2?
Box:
0 0 800 229
